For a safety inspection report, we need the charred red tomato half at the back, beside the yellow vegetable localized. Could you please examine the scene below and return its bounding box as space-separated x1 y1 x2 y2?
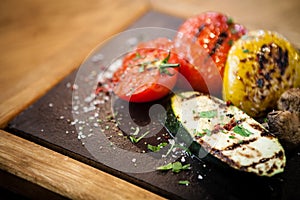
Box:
175 12 246 96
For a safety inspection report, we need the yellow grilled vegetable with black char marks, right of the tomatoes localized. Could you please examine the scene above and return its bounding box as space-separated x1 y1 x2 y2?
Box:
223 31 300 117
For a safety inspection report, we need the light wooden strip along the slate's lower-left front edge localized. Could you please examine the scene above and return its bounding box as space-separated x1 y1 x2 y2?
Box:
0 130 162 199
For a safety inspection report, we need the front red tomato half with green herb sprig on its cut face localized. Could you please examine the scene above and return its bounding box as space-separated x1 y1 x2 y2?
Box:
113 38 179 102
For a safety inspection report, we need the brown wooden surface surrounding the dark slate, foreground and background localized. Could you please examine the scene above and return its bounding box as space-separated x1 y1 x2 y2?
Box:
0 0 300 199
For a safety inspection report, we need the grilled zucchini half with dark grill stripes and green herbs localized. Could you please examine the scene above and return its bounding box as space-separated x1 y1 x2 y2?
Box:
167 92 286 176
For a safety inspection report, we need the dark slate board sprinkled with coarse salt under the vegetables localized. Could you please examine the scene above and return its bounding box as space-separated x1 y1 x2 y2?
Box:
6 11 300 199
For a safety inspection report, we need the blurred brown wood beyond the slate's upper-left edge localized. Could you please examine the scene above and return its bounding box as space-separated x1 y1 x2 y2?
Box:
0 0 149 127
